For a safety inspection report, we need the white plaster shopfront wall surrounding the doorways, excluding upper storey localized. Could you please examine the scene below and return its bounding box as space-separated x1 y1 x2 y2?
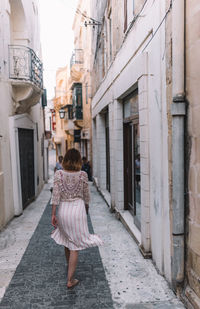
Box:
92 0 171 281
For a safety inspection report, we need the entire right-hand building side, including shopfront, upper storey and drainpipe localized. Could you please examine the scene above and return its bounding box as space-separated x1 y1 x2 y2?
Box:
88 0 200 309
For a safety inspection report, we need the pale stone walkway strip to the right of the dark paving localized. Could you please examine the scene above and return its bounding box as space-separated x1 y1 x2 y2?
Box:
90 186 185 309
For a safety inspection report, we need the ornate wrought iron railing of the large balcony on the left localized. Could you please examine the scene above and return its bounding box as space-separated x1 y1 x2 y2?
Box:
9 45 43 89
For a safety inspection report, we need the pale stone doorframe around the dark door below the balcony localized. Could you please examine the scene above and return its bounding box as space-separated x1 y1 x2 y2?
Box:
9 114 37 216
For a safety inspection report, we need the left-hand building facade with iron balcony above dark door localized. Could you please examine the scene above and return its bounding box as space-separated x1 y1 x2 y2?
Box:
0 0 44 228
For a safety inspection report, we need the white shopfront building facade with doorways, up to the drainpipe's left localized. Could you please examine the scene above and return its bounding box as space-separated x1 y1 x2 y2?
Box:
91 1 171 279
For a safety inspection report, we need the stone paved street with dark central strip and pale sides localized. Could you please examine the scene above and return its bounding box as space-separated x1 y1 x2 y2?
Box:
0 152 184 309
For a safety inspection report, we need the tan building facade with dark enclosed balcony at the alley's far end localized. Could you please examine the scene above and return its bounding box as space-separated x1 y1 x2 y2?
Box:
69 0 92 161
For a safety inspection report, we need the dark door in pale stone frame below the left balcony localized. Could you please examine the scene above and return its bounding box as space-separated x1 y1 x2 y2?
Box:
18 128 35 209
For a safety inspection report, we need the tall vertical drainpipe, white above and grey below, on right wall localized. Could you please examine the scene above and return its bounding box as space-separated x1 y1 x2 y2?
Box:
171 0 186 292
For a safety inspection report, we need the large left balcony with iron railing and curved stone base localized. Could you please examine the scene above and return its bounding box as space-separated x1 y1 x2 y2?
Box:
9 45 43 113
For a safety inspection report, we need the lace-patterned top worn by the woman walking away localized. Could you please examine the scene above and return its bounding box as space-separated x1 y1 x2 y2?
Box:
51 170 90 205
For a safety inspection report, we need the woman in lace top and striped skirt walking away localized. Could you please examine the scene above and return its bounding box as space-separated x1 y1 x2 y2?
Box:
51 148 102 288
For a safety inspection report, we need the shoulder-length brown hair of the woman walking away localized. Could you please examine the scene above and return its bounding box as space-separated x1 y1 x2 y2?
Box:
62 148 82 171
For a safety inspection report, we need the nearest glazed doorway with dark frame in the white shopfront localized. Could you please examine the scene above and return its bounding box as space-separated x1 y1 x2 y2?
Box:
123 91 141 230
